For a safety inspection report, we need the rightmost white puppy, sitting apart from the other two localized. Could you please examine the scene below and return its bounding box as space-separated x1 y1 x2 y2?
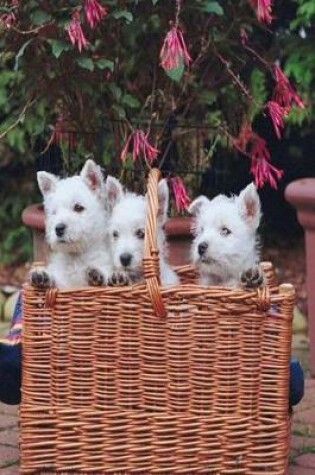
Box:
188 184 263 287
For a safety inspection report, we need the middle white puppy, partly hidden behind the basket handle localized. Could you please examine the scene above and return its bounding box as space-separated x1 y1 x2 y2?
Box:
106 177 179 285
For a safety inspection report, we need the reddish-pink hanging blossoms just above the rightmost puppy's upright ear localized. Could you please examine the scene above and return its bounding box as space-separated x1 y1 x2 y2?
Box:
233 123 283 188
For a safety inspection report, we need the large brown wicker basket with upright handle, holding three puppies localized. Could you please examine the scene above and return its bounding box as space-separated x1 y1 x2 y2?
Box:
20 171 294 475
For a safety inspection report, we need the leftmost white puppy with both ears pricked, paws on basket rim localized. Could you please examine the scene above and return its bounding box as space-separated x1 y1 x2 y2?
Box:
30 160 112 288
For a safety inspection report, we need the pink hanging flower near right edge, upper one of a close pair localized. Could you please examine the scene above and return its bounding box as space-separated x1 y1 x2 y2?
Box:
272 64 304 112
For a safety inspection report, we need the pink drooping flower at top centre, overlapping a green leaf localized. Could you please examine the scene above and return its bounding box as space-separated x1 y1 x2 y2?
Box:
160 26 191 69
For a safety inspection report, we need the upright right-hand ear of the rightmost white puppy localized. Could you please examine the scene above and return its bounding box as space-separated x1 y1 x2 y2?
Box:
238 183 261 229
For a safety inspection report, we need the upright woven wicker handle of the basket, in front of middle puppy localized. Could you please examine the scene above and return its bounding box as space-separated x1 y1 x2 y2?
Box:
143 168 167 318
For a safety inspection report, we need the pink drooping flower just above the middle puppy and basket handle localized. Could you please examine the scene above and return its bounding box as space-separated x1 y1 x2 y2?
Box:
120 129 159 163
